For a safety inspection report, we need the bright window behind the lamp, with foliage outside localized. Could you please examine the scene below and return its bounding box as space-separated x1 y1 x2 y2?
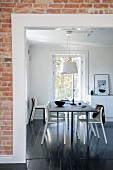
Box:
53 54 82 100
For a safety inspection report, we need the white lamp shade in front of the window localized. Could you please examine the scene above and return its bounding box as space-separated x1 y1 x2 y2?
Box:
60 61 78 74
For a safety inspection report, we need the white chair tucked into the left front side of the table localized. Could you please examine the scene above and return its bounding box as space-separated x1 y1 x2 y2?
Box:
41 103 66 145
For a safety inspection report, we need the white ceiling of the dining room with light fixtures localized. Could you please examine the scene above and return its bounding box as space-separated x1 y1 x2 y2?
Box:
26 27 113 47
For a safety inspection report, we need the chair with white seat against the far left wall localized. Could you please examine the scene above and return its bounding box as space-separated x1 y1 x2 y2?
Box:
29 97 46 122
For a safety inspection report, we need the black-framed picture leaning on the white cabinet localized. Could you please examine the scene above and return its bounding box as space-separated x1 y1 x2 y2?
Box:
94 74 109 95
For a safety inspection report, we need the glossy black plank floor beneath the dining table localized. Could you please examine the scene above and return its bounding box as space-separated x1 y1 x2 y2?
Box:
0 120 113 170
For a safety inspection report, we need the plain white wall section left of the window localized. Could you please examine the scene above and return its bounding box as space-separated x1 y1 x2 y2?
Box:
30 47 50 104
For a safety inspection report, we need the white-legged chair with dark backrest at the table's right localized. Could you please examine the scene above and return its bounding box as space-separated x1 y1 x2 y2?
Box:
79 105 107 144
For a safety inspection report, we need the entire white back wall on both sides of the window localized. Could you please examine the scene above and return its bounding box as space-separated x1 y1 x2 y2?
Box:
30 46 113 111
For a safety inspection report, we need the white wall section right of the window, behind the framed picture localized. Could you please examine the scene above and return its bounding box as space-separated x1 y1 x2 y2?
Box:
89 47 113 94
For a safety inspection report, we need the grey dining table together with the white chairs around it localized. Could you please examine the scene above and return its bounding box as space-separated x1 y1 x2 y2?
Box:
29 97 107 149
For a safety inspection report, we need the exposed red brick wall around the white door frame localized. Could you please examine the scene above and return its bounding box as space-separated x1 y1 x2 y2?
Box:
0 0 113 155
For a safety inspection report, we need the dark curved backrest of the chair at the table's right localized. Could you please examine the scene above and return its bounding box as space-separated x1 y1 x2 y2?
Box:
93 105 105 124
